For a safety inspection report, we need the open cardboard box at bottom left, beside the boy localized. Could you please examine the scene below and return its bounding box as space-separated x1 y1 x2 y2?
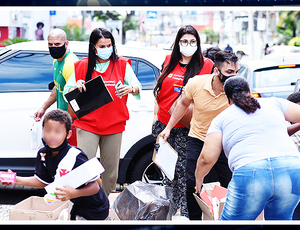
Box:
9 196 69 220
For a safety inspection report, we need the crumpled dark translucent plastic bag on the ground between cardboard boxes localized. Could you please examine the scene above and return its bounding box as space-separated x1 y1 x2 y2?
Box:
112 181 176 220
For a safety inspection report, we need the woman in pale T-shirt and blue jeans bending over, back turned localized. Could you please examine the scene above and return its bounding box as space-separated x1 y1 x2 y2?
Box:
195 77 300 220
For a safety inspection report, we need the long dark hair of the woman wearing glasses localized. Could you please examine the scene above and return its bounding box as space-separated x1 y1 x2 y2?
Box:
153 25 204 98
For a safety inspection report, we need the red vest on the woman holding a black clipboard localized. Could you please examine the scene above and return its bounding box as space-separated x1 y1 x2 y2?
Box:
74 57 131 135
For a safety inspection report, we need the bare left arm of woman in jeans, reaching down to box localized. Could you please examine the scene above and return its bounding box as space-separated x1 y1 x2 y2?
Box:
195 133 222 193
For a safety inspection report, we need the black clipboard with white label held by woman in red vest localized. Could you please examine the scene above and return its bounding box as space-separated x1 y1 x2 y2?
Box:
65 75 113 118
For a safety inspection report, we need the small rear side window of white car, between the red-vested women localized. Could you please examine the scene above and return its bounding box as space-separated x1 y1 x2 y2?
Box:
137 61 156 89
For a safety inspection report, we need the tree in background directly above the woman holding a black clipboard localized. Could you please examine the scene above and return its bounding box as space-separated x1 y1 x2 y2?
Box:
93 11 139 44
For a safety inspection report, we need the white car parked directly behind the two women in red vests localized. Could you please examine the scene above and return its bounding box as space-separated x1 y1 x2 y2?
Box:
0 41 170 184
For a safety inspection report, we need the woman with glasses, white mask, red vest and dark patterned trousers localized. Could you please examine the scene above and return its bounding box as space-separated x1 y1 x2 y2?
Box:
152 25 214 217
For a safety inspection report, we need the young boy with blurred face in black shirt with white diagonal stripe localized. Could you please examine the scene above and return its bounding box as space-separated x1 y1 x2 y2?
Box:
3 109 109 220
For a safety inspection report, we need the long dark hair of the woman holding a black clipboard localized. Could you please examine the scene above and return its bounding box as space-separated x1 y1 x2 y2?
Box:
85 28 119 81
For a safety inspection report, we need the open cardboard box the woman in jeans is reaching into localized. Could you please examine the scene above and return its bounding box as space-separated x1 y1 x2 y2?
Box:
194 185 264 220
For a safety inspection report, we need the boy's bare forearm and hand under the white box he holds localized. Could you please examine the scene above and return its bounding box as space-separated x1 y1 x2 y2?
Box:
55 180 100 201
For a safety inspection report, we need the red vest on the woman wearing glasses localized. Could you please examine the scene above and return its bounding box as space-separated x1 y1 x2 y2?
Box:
157 55 214 127
